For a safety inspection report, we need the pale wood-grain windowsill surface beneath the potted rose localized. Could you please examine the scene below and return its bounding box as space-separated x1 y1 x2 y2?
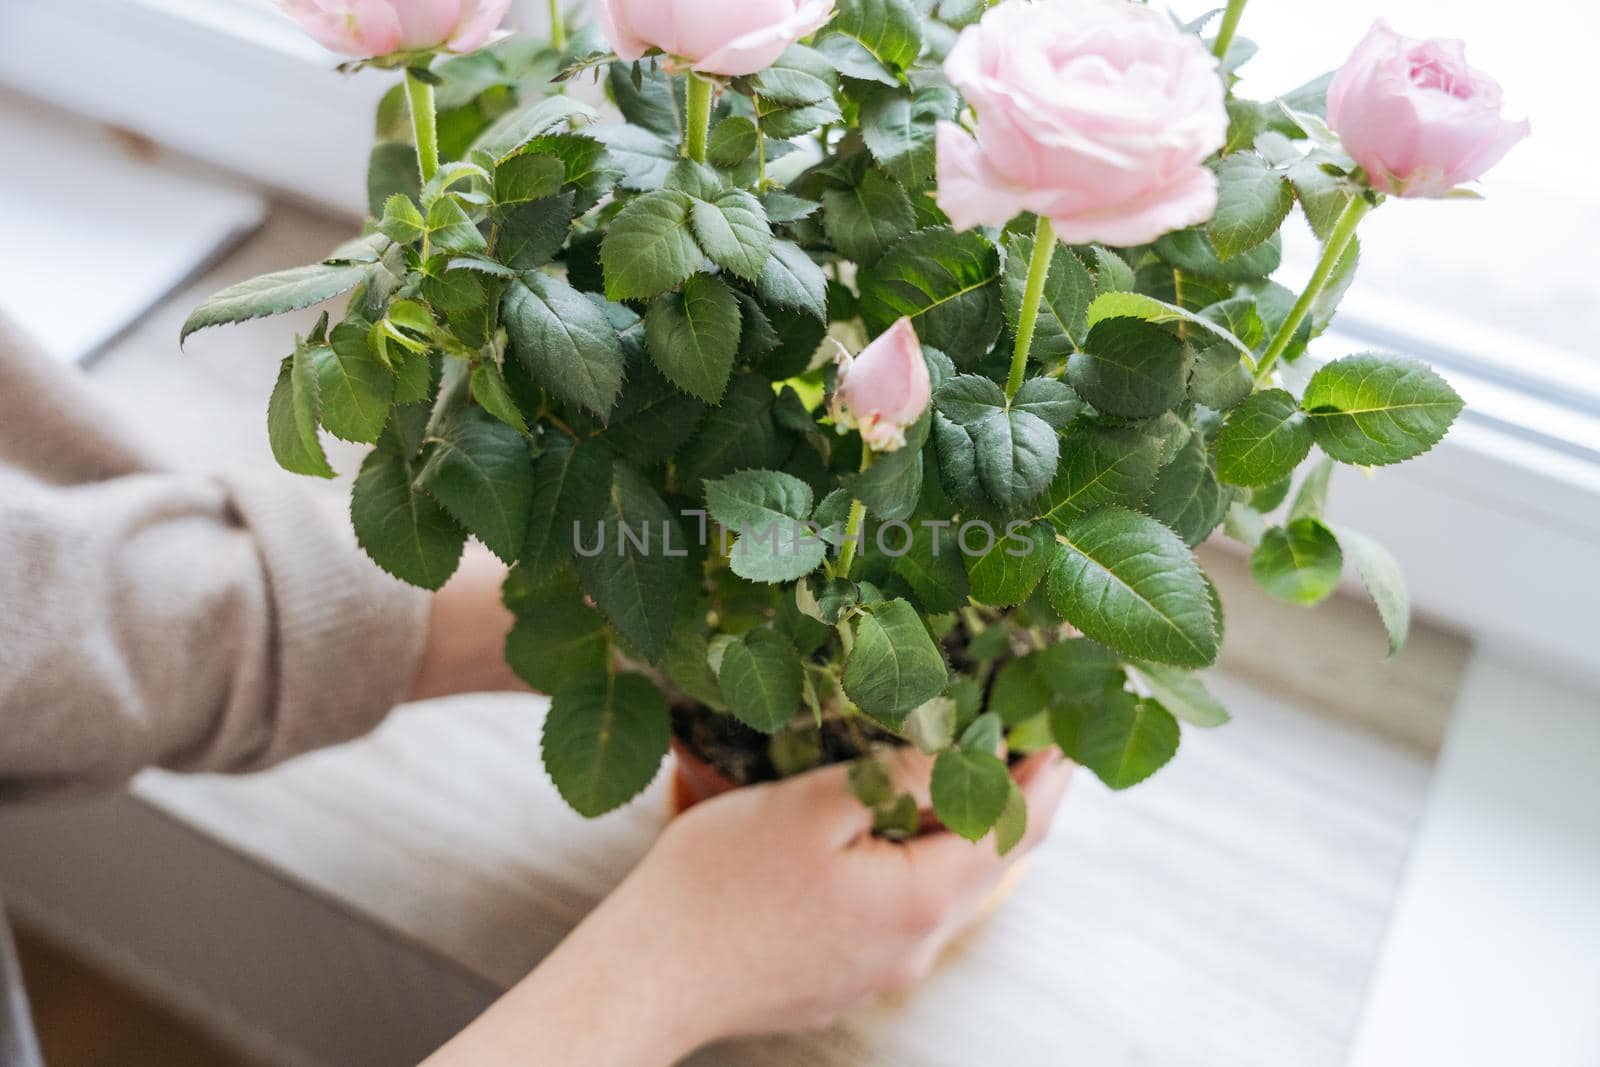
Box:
75 210 1466 1067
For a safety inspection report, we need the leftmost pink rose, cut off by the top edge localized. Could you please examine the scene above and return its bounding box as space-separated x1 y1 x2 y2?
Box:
278 0 510 58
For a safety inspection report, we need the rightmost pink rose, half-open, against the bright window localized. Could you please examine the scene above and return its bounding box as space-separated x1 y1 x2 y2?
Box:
1328 19 1531 197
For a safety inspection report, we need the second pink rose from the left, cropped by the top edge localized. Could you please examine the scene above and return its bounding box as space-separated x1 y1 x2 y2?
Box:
600 0 834 77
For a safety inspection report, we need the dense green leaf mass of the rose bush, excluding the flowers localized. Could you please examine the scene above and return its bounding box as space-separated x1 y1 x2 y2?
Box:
184 0 1461 848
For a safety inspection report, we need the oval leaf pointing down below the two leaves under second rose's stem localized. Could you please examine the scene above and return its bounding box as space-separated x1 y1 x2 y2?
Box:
645 274 739 403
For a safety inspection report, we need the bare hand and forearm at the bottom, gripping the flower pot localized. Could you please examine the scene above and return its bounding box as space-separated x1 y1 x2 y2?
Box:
429 752 1070 1067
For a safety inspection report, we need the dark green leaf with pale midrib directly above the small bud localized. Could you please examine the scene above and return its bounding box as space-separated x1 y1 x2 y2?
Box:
858 227 1003 366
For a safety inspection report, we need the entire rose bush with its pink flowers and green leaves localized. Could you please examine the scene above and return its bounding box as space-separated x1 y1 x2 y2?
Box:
184 0 1526 849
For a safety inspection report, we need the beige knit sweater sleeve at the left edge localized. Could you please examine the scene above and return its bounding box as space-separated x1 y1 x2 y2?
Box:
0 313 427 801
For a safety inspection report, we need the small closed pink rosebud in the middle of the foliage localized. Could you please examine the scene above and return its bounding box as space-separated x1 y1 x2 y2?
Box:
830 318 933 453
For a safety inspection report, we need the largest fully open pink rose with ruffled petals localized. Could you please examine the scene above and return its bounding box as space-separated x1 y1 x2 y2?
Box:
936 0 1227 245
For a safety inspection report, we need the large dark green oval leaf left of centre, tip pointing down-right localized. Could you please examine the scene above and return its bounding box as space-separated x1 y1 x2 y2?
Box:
501 270 624 418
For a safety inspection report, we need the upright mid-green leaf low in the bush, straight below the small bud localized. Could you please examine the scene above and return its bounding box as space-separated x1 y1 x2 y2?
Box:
845 600 950 729
